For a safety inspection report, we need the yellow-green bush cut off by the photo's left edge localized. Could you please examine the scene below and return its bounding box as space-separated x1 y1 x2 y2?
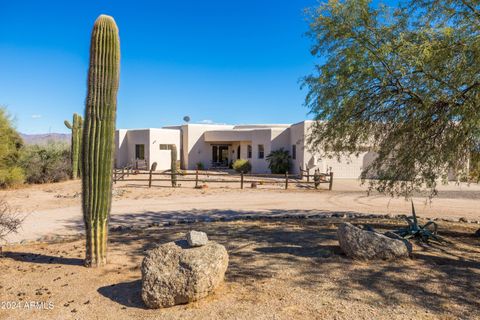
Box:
0 107 24 188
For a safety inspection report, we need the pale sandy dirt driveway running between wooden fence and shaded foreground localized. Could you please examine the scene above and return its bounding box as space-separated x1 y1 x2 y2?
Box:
0 180 480 242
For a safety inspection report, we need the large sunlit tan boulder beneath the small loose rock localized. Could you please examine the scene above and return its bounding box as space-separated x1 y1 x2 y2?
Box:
142 240 228 309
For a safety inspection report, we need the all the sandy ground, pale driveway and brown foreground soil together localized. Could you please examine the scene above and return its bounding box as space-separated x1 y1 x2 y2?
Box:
0 180 480 320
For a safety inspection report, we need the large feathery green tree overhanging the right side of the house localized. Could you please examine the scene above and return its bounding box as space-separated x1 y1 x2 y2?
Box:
304 0 480 195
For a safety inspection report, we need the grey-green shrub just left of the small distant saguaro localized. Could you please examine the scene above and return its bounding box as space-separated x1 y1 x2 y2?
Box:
20 143 72 183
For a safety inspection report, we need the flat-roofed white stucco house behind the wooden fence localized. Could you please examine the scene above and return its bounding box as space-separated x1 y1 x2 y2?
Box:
115 121 374 178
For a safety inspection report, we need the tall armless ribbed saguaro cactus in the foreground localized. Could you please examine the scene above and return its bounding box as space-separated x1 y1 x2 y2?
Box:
82 15 120 267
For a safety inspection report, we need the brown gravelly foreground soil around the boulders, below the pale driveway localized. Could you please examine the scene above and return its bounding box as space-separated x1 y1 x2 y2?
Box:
0 218 480 320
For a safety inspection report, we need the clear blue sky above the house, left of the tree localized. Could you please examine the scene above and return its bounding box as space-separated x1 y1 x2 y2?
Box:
0 0 398 133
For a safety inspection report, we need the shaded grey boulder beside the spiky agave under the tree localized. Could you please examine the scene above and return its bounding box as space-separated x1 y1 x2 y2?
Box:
337 223 410 260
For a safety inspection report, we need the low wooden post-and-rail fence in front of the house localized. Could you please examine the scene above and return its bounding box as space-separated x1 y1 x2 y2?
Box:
113 165 333 190
